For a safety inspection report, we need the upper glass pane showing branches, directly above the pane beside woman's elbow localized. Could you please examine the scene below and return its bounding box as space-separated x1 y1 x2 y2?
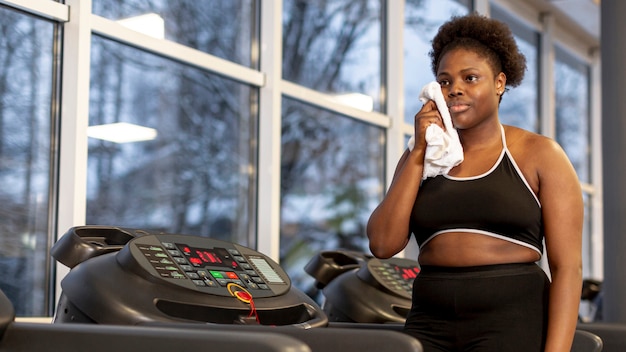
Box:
283 0 382 111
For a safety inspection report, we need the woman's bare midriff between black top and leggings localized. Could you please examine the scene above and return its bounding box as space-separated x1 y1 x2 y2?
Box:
419 232 540 267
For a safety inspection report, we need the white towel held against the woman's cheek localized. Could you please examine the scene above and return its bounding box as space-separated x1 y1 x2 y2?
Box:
407 82 463 180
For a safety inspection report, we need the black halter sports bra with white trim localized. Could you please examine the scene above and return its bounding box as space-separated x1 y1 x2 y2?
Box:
409 128 544 255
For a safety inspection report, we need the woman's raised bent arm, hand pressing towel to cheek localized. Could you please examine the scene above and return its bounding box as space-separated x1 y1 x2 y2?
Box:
367 101 436 258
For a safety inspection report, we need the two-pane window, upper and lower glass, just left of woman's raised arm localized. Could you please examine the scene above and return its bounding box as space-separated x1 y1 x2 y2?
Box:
280 0 385 291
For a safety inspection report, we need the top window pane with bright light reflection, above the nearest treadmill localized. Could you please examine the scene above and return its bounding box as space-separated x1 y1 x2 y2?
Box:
92 0 258 68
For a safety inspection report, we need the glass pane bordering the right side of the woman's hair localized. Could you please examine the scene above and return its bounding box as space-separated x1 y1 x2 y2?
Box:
491 6 539 132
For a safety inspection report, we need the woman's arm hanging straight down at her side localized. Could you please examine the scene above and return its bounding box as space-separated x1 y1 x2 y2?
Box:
537 139 584 352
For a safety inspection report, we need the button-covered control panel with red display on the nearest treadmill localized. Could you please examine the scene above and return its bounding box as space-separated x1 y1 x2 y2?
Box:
118 234 291 297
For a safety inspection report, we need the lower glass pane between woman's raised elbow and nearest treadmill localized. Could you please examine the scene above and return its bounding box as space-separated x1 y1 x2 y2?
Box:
280 99 385 300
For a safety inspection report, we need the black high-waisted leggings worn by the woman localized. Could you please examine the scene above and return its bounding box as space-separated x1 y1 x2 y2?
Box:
405 263 550 352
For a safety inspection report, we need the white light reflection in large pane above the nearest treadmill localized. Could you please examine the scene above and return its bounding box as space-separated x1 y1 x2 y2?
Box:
87 122 157 143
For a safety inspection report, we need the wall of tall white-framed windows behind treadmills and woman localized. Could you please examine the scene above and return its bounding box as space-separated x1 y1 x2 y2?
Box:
0 0 602 316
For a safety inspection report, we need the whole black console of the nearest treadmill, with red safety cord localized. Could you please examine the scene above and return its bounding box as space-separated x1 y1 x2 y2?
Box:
51 226 328 329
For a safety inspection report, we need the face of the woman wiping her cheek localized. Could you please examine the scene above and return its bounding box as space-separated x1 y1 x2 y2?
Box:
437 48 506 129
